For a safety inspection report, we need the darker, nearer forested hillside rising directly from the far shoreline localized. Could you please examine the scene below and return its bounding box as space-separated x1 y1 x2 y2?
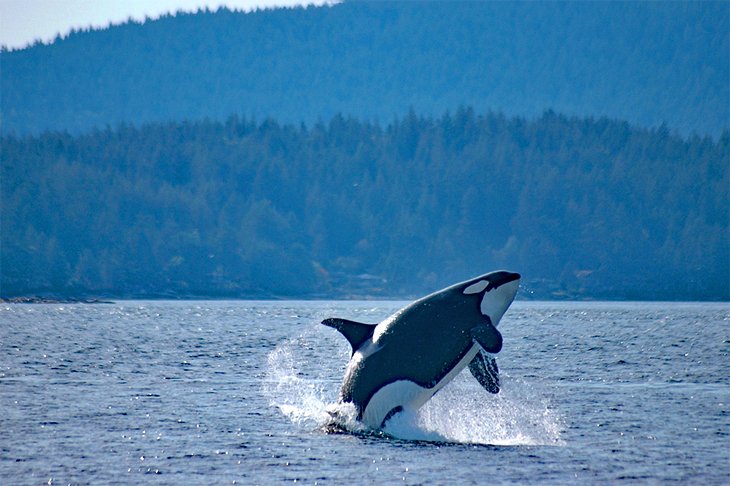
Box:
0 110 730 299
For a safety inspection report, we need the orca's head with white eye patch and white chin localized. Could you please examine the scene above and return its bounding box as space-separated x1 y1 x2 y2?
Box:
462 270 520 327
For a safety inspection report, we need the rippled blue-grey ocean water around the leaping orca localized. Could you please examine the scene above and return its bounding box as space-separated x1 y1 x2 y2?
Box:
0 301 730 484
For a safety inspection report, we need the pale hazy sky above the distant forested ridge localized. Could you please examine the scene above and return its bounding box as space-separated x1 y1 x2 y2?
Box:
0 0 334 48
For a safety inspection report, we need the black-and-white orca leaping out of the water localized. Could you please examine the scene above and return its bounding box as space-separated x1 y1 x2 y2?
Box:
322 271 520 429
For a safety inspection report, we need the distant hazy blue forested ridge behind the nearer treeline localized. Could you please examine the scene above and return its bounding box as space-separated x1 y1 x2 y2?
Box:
0 1 730 137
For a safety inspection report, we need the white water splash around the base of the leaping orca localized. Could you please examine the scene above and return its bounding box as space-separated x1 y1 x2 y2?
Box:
264 337 565 446
